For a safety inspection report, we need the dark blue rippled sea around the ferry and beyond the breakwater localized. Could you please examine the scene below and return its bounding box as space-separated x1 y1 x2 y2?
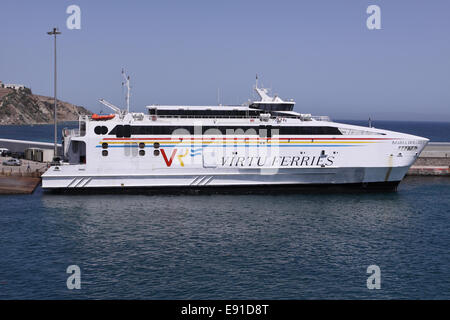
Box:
0 121 450 299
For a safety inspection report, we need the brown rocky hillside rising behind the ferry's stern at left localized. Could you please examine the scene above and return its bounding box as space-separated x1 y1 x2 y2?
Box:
0 88 92 125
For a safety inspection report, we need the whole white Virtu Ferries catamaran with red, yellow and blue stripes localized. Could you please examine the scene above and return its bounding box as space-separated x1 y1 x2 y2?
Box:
42 78 429 193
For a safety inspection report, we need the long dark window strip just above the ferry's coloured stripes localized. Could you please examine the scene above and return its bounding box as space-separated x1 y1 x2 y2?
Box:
109 125 342 138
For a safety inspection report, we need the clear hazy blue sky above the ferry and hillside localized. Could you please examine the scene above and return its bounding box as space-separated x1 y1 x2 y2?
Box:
0 0 450 121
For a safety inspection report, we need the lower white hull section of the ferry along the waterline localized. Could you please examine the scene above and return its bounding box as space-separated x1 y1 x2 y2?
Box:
43 167 408 192
